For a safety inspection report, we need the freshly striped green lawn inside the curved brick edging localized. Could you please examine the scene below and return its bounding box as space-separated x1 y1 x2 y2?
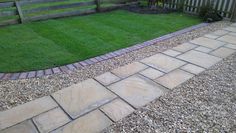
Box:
0 10 201 72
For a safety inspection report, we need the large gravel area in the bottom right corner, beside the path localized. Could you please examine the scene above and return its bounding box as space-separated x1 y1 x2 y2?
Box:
104 53 236 133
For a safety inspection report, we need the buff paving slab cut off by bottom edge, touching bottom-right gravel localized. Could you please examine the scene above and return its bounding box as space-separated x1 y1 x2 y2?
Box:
52 110 112 133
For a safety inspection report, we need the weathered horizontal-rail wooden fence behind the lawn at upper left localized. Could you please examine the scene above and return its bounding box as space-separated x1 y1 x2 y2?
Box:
0 0 138 26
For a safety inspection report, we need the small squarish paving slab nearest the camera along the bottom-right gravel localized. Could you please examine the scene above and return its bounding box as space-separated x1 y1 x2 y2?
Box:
101 99 134 121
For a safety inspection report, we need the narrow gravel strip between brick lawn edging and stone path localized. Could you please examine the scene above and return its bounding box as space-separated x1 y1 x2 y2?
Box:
0 21 230 111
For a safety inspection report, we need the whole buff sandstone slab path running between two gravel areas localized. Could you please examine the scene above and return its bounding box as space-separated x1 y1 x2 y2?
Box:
0 24 236 133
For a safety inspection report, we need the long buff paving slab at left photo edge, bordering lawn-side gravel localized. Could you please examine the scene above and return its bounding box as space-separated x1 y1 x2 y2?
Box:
0 96 58 130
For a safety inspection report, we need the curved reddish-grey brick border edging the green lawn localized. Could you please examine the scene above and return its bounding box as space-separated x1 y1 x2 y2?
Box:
0 23 209 80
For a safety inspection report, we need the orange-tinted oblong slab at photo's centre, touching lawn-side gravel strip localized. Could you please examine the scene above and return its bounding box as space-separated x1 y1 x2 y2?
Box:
112 62 147 78
